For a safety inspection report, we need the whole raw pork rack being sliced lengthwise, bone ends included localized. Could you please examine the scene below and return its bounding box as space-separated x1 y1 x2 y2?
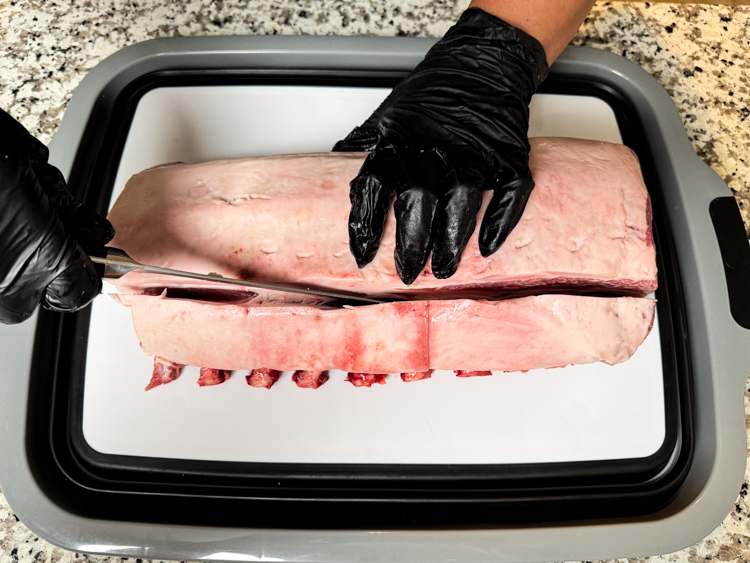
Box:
109 138 657 389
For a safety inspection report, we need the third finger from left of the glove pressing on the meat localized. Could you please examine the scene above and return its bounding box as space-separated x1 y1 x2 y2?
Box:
432 169 484 279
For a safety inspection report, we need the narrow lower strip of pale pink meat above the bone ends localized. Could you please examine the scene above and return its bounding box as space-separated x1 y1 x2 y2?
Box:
116 295 655 376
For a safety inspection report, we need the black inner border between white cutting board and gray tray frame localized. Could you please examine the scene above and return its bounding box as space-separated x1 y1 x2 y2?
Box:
22 69 694 528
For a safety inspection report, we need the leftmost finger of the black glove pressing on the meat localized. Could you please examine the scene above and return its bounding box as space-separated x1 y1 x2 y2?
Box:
349 147 406 268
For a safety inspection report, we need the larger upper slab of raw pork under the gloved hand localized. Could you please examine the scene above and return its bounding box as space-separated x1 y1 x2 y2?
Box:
109 138 656 298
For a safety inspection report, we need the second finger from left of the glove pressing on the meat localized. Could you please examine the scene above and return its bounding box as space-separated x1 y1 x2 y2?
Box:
393 148 447 285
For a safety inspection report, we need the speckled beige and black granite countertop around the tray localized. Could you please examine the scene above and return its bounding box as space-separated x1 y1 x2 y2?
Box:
0 0 750 563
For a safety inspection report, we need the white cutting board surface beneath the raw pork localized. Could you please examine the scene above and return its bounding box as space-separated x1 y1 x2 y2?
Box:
83 86 665 464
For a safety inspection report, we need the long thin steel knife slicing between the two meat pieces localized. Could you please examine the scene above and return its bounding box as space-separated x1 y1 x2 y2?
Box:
91 247 388 304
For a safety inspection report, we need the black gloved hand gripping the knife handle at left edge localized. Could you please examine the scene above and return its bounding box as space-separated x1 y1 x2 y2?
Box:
0 111 115 324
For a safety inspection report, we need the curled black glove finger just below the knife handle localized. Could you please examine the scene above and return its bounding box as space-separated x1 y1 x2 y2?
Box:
43 240 102 313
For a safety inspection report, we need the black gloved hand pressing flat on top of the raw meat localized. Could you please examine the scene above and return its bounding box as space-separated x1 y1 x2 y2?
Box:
333 8 549 284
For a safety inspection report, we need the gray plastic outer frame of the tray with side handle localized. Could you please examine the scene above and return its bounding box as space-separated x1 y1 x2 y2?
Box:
0 37 750 562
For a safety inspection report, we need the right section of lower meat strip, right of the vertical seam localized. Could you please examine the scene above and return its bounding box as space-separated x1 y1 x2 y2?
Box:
429 295 656 375
